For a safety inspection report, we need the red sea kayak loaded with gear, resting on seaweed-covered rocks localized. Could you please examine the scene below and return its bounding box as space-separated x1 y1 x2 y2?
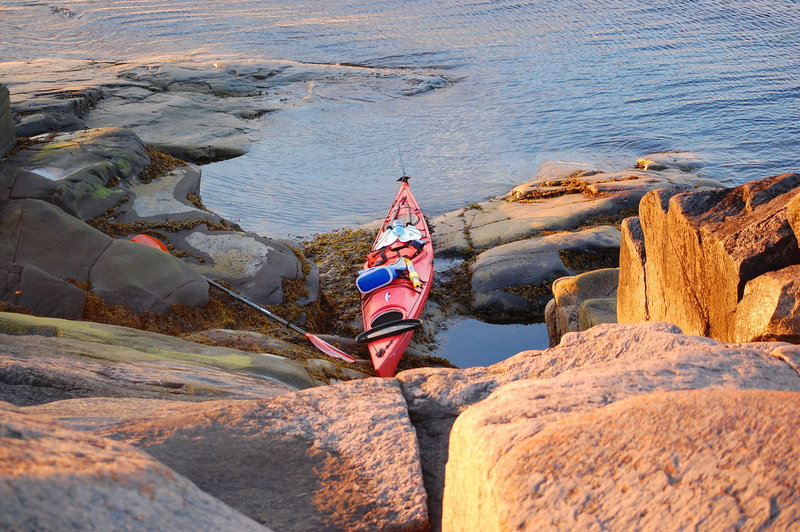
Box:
356 176 433 377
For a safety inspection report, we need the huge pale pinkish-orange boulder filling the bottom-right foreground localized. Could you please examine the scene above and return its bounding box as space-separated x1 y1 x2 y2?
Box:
439 324 800 530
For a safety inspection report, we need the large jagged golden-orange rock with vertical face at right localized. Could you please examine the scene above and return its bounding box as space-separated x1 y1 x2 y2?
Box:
620 174 800 341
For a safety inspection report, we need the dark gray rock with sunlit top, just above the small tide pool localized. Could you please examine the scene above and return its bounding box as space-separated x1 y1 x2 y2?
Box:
471 226 619 321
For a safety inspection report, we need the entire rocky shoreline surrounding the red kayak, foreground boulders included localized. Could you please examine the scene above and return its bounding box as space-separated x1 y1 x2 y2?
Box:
0 62 800 530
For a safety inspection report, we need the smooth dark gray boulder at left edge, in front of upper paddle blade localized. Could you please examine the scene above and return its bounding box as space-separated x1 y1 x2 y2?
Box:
0 200 208 317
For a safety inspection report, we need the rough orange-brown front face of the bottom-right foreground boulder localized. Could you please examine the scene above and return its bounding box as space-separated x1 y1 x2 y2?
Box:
445 390 800 530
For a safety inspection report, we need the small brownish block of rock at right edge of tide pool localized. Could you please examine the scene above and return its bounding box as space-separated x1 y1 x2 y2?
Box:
545 268 619 347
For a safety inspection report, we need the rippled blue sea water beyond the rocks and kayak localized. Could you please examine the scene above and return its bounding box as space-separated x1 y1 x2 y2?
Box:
0 0 800 235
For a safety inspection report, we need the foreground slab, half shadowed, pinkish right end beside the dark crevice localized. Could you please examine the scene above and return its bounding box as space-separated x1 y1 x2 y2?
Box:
101 379 429 531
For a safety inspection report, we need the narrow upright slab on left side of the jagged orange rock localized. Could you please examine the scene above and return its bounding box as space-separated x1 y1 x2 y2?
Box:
617 216 649 323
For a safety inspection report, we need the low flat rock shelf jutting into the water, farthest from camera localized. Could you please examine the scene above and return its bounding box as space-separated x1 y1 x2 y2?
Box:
3 59 449 163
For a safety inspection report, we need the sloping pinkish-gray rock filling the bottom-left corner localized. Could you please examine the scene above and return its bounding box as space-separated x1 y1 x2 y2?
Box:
0 402 269 532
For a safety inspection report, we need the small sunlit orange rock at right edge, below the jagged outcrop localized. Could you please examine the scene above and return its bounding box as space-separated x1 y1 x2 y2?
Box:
733 265 800 344
